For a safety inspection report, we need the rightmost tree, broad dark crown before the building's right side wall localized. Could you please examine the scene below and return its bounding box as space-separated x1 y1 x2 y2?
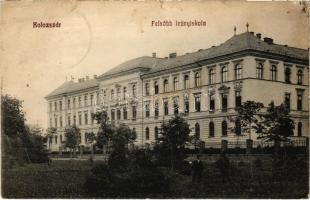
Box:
256 101 295 153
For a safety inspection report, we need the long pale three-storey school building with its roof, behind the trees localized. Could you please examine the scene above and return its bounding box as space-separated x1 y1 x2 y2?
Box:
46 32 309 151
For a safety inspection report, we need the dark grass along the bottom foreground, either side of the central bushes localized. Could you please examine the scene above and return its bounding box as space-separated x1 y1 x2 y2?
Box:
2 155 309 198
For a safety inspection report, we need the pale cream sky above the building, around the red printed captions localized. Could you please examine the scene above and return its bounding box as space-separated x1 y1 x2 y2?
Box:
0 0 309 128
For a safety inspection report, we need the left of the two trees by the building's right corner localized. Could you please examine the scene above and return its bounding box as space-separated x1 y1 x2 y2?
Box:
231 101 264 139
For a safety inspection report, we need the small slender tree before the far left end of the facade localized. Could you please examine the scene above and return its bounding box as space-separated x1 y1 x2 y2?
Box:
65 125 81 157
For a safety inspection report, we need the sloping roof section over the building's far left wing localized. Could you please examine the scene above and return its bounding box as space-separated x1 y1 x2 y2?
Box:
45 79 99 98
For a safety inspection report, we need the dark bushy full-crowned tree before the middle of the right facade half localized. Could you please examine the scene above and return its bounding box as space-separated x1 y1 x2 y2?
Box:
155 115 191 169
